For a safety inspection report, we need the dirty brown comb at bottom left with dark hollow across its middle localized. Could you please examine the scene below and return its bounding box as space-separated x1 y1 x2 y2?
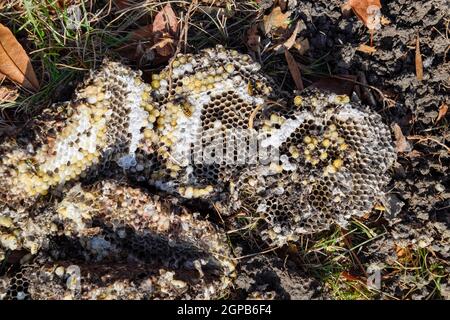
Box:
4 180 234 299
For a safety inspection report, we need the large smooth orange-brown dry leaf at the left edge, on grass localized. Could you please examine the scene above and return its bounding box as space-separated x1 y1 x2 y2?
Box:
0 23 39 91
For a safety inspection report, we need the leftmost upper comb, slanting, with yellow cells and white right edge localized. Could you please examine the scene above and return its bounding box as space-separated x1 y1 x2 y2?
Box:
0 61 150 203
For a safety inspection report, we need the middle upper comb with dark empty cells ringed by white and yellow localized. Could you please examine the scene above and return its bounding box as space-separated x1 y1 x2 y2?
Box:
135 46 272 198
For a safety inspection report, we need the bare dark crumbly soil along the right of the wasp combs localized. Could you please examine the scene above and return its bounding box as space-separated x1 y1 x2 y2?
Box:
234 0 450 299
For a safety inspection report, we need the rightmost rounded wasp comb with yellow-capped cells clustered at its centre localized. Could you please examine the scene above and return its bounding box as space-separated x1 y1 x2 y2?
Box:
236 90 395 245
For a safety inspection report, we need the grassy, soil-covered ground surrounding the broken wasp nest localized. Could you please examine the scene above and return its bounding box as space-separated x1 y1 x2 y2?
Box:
0 0 450 299
